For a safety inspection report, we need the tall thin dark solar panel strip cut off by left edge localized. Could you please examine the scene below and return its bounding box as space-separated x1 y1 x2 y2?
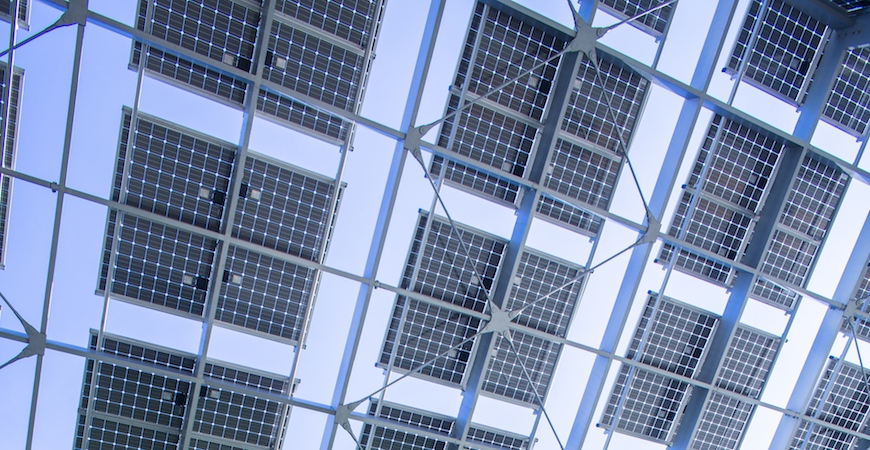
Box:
0 68 26 264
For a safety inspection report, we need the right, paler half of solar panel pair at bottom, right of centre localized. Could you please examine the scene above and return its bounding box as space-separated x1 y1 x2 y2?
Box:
691 326 780 450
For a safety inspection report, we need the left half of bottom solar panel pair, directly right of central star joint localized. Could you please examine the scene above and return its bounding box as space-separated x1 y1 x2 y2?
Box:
601 293 718 444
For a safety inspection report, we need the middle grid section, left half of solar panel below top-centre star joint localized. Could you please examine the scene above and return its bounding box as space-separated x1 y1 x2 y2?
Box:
438 94 538 176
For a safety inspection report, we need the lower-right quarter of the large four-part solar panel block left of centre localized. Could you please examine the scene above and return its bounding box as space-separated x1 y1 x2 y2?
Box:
215 246 316 340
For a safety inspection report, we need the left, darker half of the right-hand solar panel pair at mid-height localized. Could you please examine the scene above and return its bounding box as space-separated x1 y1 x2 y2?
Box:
659 115 782 284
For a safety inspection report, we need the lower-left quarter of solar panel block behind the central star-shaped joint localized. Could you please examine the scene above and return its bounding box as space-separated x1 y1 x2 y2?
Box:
379 297 481 384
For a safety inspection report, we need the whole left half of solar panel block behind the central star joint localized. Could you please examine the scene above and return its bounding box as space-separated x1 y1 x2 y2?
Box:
379 212 507 383
